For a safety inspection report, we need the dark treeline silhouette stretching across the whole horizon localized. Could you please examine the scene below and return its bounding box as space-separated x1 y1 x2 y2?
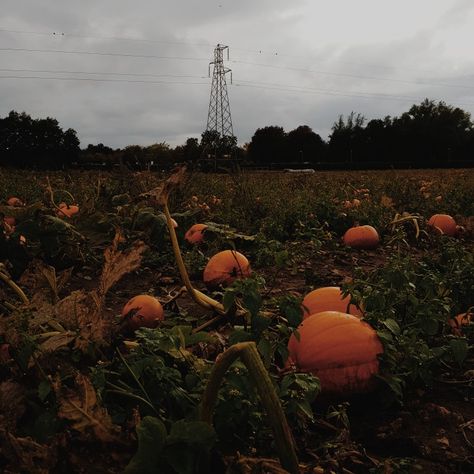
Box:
0 99 474 170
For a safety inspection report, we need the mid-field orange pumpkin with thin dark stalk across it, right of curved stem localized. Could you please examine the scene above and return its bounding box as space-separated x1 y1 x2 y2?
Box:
203 250 251 288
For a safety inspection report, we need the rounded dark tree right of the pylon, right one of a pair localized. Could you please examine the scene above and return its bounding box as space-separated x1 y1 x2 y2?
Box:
287 125 325 162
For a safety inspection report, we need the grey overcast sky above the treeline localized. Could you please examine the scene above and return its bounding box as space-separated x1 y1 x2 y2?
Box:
0 0 474 148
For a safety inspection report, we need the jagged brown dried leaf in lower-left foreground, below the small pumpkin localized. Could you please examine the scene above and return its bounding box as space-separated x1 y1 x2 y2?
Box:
55 374 119 442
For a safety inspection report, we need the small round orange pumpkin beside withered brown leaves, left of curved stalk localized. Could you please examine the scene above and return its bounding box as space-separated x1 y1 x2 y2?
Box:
122 295 164 330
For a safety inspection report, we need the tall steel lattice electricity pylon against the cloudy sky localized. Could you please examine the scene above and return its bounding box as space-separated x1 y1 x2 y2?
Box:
206 44 234 137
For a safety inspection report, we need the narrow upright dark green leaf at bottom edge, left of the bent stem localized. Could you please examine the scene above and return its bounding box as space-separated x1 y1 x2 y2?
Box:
124 416 167 474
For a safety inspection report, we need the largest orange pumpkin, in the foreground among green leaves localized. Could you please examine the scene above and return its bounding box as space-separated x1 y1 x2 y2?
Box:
287 311 383 395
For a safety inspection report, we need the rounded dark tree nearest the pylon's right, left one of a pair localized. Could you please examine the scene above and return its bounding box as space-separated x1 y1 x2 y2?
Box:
248 125 289 163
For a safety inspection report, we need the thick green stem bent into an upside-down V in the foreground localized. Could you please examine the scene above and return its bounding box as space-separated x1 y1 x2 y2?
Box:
199 342 300 474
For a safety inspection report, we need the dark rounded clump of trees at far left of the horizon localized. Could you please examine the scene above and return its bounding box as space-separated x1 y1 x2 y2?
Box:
0 111 80 169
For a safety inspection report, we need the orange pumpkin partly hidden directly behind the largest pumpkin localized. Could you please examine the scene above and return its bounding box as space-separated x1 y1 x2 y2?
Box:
302 286 363 318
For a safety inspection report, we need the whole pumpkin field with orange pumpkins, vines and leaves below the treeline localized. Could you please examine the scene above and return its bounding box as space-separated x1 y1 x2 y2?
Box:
0 169 474 474
